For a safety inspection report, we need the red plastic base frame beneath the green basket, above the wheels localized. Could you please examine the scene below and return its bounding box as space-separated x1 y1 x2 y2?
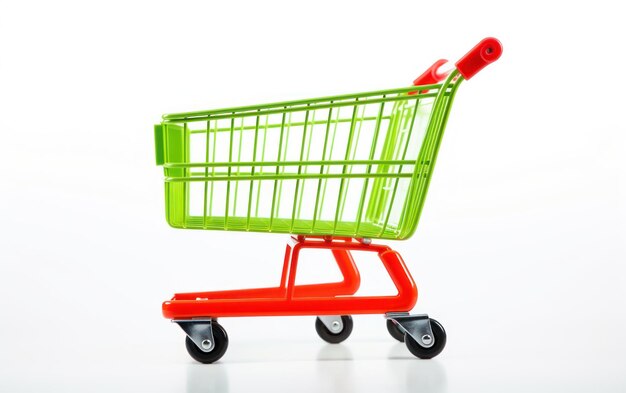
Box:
163 236 417 319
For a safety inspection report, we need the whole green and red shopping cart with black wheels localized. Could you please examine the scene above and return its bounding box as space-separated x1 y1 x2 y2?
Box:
155 38 502 363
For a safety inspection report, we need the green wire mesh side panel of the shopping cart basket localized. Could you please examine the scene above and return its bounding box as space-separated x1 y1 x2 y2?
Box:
163 87 444 239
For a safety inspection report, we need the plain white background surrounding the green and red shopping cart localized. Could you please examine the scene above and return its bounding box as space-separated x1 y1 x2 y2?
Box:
0 1 626 392
